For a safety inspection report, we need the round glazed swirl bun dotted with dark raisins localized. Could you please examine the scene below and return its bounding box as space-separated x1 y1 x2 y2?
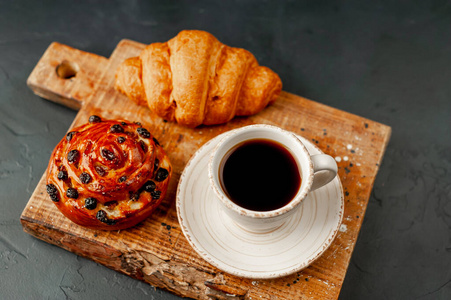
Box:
47 116 172 230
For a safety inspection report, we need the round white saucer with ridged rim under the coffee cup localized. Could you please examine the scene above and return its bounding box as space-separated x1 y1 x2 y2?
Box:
176 131 344 279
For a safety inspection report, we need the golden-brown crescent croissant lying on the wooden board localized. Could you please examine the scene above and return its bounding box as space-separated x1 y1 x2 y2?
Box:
115 30 282 127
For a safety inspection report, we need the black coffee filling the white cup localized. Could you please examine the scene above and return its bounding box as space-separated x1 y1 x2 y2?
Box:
219 139 301 211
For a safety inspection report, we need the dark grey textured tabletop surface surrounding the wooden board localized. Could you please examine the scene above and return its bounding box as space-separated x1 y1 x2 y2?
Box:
0 1 451 299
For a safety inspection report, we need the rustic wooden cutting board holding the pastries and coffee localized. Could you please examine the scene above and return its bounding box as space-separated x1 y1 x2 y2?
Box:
21 40 391 299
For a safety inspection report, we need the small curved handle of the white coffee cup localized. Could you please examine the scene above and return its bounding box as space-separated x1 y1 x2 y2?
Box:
310 154 338 191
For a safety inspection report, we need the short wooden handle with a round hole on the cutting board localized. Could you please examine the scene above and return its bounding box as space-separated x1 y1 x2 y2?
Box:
27 42 108 110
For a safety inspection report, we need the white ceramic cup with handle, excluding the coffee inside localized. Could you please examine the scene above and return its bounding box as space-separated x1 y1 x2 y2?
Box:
208 124 337 233
